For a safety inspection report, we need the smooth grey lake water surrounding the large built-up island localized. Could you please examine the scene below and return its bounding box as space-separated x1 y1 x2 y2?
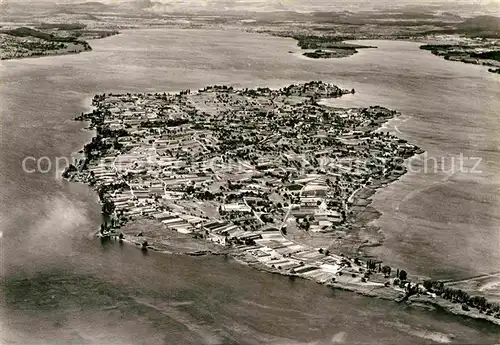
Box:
0 29 500 344
